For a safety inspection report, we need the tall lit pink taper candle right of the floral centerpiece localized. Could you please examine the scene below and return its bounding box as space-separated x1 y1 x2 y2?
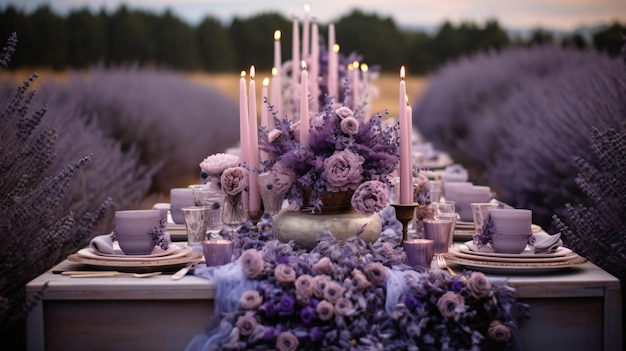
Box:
398 66 413 204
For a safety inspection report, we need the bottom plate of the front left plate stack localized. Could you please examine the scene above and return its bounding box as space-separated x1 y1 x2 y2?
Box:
67 251 204 272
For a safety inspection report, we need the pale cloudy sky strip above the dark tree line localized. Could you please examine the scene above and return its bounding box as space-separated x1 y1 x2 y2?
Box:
0 0 626 31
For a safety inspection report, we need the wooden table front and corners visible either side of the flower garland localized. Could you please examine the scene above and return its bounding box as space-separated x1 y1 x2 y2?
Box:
26 253 622 351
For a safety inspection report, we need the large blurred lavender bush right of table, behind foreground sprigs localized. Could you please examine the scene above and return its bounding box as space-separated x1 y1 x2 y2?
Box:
414 46 626 231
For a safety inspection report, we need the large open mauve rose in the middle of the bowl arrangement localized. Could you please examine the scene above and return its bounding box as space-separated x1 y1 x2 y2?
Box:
322 150 365 192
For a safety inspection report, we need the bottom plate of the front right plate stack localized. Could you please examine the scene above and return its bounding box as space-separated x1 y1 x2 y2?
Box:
443 252 587 275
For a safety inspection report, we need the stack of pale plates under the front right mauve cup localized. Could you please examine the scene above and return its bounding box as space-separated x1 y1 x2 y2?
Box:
444 241 587 274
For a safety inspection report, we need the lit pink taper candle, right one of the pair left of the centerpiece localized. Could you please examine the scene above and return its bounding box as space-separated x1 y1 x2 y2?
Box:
244 66 261 211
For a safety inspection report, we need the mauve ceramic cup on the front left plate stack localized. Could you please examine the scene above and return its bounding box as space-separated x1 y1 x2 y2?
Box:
115 210 161 255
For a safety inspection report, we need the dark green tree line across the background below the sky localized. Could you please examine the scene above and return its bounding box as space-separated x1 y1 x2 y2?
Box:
0 5 624 73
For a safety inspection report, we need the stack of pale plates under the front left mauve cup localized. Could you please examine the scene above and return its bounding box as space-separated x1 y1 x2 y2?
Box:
67 242 203 272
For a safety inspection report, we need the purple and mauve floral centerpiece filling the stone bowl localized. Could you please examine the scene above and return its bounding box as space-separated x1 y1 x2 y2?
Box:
259 95 398 213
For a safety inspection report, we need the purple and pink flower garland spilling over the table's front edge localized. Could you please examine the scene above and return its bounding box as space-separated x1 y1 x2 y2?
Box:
188 210 528 350
